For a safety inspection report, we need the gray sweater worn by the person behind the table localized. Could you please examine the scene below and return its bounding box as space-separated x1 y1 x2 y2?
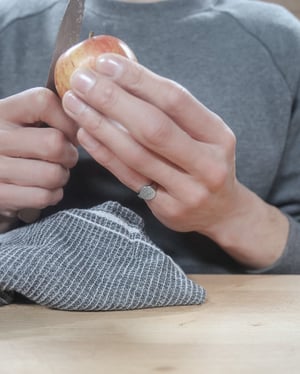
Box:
0 0 300 273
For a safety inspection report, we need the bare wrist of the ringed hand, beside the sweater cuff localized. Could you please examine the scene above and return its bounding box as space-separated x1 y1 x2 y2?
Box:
204 184 289 268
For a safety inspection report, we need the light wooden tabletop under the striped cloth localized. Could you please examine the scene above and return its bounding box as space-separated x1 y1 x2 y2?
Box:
0 275 300 374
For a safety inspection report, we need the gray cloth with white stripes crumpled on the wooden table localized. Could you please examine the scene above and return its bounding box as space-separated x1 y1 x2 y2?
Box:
0 201 205 311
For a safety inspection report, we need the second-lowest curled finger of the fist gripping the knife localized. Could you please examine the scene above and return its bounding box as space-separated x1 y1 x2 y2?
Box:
0 156 70 190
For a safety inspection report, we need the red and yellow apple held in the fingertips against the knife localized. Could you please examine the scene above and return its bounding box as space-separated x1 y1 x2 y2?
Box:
54 35 137 98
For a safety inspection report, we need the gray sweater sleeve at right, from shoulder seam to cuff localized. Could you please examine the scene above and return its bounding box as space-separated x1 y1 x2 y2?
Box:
226 1 300 274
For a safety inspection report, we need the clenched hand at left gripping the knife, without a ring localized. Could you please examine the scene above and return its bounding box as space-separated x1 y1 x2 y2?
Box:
0 88 78 216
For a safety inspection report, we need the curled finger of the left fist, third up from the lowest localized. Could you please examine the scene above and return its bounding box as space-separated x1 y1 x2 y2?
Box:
0 127 78 168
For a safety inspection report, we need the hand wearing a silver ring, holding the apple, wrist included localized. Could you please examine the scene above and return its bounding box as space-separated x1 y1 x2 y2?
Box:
63 55 287 266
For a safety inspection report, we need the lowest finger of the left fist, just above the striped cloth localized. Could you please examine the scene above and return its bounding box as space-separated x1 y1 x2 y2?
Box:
0 183 63 211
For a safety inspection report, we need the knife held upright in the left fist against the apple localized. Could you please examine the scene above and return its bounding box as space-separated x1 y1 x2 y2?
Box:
17 0 85 223
